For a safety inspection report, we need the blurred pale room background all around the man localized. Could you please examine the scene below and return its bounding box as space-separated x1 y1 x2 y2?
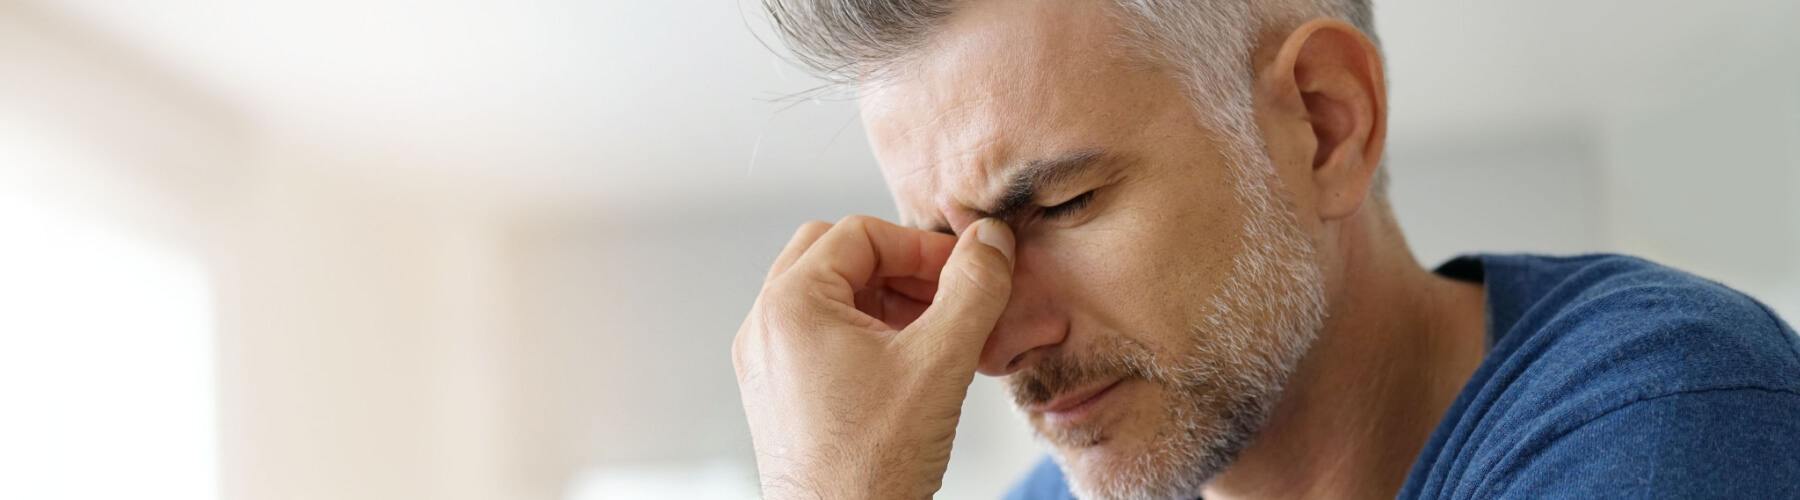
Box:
0 0 1800 500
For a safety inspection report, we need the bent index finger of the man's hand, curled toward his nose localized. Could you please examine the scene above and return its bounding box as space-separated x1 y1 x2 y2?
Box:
783 216 956 306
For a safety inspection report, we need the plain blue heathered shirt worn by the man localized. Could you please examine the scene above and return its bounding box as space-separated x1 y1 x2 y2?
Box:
1006 255 1800 498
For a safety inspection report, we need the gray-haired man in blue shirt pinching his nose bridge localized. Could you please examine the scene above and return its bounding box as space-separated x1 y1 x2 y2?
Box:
733 0 1800 498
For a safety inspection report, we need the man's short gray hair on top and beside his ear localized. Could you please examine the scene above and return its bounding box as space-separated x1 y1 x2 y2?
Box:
763 0 1388 196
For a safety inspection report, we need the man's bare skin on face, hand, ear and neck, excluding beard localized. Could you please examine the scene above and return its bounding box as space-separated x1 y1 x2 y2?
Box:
733 0 1483 498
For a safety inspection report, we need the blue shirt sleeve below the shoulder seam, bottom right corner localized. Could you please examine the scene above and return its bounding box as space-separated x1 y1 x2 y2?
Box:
1478 388 1800 498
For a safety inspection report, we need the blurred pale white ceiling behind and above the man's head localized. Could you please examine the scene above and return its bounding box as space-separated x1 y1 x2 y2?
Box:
9 0 1800 205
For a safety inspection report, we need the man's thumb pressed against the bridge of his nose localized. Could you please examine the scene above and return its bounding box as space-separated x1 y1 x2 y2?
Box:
902 219 1015 356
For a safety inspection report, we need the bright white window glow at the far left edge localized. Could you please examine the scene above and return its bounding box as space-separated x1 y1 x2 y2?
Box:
0 161 220 500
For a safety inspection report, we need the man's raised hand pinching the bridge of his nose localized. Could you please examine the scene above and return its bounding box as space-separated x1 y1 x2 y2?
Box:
731 218 1013 498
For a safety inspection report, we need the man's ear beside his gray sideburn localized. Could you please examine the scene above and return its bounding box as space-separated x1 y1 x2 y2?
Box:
1262 20 1388 219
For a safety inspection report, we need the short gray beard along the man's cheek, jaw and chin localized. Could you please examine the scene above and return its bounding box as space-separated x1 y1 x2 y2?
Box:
1036 155 1325 500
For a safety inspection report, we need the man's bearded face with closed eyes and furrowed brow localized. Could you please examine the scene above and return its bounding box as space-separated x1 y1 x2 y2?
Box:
862 0 1323 496
